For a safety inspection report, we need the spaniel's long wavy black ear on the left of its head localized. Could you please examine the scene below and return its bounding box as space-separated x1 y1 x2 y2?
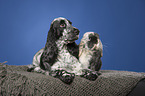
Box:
40 24 59 70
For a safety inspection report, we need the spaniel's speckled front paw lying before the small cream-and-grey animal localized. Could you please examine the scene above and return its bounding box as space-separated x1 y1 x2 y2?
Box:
80 69 100 81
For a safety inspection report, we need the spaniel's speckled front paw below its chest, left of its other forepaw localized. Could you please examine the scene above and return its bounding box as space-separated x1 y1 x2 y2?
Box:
51 70 75 84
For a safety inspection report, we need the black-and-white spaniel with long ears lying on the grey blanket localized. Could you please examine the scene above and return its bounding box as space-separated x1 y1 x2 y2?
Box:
28 17 101 84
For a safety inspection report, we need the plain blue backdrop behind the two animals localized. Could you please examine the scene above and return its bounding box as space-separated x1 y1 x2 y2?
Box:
0 0 145 72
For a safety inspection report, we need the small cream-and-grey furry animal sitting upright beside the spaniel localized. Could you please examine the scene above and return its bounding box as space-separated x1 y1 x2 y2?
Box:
79 32 103 72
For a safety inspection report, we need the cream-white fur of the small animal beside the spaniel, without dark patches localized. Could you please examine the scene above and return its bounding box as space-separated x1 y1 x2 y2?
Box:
79 32 103 69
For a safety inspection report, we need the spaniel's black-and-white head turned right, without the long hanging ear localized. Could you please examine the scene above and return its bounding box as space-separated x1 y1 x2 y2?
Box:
49 17 80 43
